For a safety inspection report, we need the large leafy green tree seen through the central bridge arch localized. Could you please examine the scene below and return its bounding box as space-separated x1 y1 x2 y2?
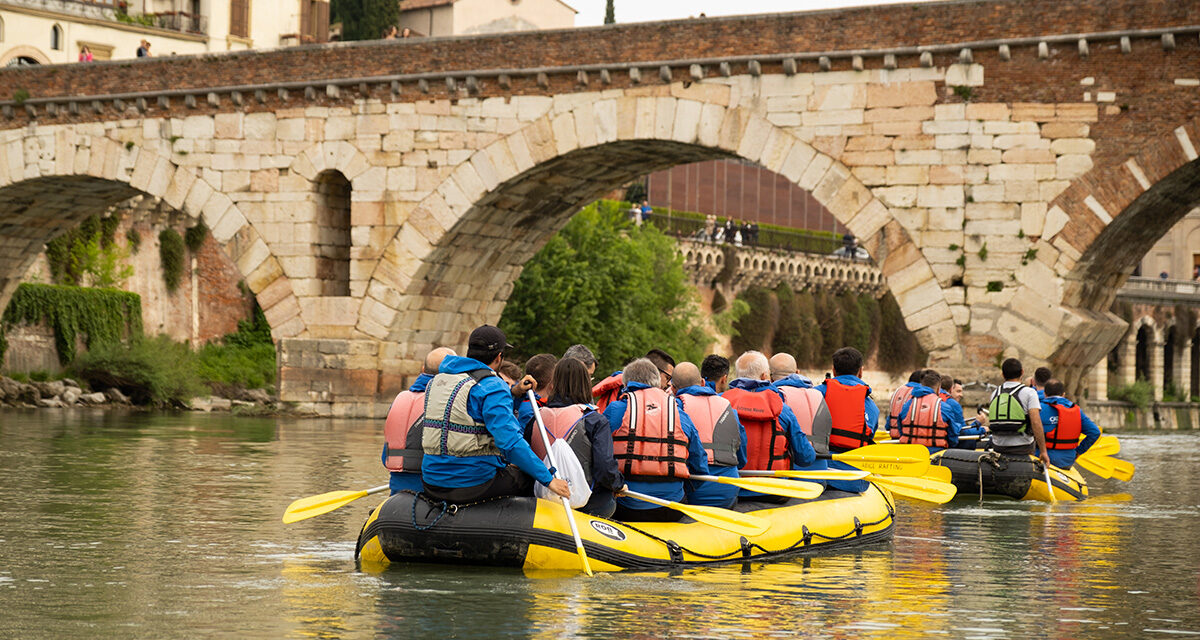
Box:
500 202 708 372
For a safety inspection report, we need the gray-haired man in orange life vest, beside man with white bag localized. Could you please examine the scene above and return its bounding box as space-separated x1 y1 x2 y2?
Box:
604 358 709 522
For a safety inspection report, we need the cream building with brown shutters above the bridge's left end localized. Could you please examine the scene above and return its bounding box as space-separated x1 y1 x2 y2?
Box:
0 0 329 65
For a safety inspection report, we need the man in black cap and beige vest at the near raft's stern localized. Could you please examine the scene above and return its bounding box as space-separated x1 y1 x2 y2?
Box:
421 324 570 503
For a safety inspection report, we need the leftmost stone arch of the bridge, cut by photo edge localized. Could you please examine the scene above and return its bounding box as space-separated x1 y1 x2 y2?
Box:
0 132 305 340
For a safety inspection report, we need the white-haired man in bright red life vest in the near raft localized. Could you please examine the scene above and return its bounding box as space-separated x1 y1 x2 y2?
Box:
724 351 816 500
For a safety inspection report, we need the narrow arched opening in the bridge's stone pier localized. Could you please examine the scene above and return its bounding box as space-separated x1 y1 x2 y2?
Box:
313 171 350 295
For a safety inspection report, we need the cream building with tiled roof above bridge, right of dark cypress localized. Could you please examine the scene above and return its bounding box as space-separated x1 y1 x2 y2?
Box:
400 0 577 36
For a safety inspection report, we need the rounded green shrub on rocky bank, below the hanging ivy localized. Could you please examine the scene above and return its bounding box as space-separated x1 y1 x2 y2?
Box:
72 335 204 407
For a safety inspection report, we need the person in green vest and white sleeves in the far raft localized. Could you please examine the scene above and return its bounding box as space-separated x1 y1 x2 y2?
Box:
988 358 1050 465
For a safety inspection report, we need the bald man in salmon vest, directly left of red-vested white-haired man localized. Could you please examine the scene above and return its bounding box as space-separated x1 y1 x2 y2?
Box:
671 363 746 509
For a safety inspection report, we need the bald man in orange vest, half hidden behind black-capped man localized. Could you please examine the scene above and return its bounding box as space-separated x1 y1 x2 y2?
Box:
383 347 457 494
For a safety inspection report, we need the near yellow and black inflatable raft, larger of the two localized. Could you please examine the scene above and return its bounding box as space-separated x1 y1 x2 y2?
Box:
355 484 895 572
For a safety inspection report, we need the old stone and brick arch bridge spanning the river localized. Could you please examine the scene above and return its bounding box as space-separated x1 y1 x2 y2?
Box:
0 0 1200 415
